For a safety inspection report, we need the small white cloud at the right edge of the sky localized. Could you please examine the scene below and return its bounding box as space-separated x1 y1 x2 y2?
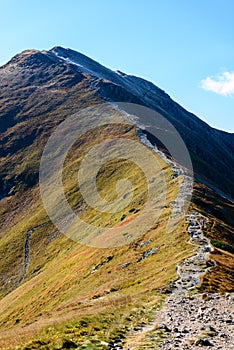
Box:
201 72 234 96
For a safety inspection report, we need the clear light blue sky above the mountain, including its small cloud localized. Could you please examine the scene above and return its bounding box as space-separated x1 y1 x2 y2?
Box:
0 0 234 132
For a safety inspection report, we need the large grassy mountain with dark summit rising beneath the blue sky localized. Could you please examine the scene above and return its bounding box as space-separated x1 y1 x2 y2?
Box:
0 47 234 349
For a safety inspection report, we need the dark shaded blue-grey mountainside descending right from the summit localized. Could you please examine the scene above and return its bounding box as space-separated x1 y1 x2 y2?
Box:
51 47 234 197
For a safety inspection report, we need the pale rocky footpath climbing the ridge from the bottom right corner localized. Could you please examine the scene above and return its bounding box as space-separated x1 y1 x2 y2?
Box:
119 123 234 350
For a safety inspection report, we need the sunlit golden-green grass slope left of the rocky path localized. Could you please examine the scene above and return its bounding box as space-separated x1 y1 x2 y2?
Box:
0 119 193 343
